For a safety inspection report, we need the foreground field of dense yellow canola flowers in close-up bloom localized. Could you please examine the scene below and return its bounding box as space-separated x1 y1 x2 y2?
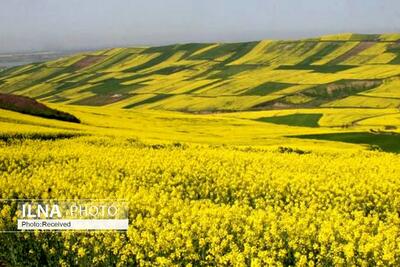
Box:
0 136 400 266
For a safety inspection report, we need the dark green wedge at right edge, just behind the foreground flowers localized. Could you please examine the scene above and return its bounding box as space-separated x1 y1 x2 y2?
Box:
290 132 400 153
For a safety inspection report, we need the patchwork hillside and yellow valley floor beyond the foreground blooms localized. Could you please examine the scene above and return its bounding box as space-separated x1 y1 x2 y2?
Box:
0 34 400 153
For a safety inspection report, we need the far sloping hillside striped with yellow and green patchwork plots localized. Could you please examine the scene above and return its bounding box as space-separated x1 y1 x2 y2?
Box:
0 33 400 112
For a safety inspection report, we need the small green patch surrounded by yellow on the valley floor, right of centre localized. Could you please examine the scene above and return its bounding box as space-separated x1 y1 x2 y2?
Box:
257 114 323 127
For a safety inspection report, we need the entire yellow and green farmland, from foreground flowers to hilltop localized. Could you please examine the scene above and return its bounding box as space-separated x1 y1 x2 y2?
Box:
0 34 400 266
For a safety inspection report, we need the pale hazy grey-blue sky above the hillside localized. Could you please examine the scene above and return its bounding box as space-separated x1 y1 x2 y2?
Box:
0 0 400 52
